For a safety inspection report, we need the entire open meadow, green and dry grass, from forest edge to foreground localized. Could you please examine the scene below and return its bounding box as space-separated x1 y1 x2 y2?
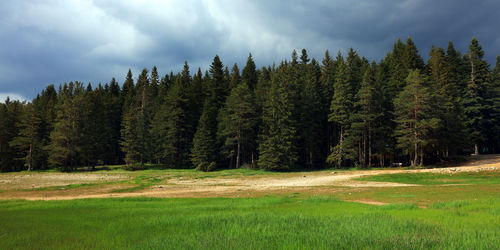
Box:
0 157 500 249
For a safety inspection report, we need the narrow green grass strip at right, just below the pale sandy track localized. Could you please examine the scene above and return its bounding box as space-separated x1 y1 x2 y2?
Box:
357 171 500 185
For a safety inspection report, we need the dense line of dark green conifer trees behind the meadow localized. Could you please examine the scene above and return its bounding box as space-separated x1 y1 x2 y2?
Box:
0 38 500 171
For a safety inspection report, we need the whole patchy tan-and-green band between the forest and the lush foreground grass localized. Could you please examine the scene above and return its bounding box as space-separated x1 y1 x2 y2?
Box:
0 155 500 207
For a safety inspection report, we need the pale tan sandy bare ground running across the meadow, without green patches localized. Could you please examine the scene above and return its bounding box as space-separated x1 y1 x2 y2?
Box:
0 155 500 201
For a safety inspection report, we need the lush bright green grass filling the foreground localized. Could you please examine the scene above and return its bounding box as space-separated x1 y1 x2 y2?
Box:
0 197 500 249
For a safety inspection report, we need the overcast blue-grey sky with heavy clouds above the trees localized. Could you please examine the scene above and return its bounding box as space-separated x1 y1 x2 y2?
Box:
0 0 500 101
